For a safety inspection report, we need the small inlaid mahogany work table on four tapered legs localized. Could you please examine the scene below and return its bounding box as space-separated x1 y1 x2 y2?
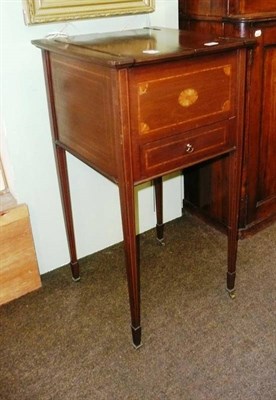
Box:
32 28 254 348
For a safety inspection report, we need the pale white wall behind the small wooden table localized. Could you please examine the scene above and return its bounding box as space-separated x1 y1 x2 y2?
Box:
1 0 181 273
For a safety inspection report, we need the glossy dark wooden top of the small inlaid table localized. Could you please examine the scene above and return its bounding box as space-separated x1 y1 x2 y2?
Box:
32 27 255 68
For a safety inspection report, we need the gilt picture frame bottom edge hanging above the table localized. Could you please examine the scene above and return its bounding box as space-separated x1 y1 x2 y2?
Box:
23 0 155 25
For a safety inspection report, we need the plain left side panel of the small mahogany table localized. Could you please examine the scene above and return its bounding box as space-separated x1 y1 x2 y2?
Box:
51 54 117 179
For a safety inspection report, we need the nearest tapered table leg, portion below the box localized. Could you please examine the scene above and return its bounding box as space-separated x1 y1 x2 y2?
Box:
119 183 142 348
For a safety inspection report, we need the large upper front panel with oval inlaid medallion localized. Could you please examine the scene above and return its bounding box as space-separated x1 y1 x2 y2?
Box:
130 53 236 137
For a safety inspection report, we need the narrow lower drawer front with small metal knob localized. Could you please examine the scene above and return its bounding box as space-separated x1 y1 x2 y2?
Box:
134 121 234 181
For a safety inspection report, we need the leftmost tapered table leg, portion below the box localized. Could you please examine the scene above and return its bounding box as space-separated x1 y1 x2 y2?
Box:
54 145 80 281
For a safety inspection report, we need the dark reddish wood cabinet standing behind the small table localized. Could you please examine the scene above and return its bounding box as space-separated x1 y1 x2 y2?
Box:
179 0 276 236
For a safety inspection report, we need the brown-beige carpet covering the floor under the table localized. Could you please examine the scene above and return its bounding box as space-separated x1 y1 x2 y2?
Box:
0 215 276 400
